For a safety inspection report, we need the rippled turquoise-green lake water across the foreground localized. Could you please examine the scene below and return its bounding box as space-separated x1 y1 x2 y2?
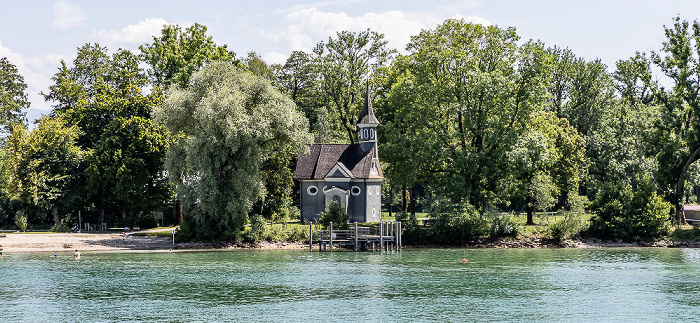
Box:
0 248 700 322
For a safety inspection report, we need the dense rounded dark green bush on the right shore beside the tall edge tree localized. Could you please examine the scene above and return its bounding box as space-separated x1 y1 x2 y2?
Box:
587 178 672 241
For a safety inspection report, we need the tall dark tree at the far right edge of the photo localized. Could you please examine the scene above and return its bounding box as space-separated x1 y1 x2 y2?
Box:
652 17 700 223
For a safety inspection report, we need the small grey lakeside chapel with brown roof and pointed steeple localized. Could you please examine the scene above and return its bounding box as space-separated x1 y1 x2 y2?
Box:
294 92 384 223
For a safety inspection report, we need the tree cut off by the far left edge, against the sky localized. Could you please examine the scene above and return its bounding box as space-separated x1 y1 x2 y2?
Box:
0 57 30 134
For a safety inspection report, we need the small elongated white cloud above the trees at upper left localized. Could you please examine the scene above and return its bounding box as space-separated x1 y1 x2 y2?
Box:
90 18 168 50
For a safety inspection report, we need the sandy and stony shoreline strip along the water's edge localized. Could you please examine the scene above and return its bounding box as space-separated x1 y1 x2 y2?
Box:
0 233 700 253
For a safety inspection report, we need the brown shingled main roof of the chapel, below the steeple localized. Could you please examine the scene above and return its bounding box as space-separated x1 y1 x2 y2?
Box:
294 144 384 180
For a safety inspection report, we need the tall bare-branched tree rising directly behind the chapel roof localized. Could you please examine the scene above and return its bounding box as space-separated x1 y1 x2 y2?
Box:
314 29 395 143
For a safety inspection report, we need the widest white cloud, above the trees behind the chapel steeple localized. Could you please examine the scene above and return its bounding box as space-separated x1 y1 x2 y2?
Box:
261 8 490 59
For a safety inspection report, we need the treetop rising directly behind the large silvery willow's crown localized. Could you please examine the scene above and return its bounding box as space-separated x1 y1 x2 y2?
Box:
139 23 238 89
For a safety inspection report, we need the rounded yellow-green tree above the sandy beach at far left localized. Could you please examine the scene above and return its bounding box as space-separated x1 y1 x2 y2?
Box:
3 117 85 226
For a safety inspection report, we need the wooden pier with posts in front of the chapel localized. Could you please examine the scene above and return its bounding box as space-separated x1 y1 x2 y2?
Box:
309 221 401 251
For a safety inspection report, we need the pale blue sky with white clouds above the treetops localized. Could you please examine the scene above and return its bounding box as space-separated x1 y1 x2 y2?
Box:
0 0 700 120
